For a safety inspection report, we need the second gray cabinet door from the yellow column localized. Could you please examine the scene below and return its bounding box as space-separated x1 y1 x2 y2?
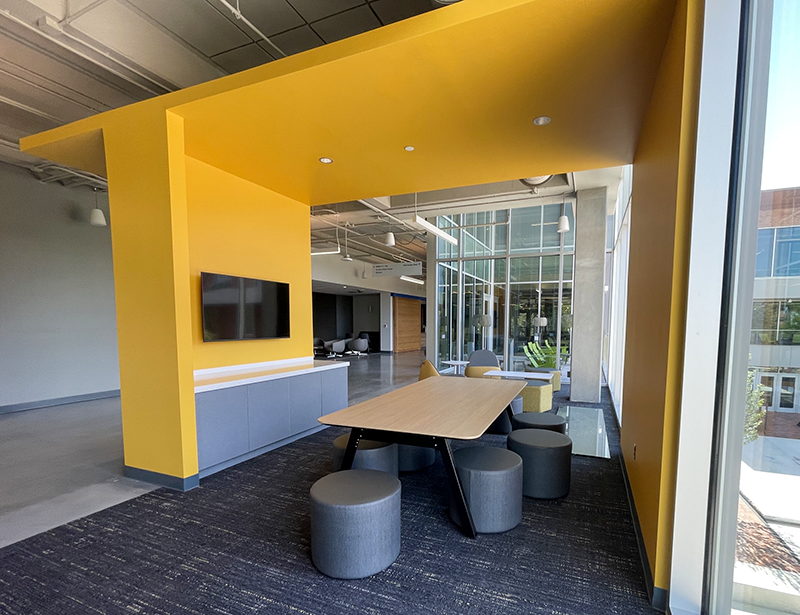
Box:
247 378 292 451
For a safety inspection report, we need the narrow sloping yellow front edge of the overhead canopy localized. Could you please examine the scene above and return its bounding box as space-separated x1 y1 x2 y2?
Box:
20 0 536 176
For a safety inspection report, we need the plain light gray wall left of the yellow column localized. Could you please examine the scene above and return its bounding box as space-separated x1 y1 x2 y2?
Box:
0 163 119 409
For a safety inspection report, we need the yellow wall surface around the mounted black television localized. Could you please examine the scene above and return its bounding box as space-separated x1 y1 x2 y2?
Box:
186 156 313 369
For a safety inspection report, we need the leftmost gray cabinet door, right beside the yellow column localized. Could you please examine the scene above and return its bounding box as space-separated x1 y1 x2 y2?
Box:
195 387 250 470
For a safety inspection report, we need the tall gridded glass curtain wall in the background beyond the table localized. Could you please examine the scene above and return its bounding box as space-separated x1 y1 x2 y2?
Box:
436 202 575 371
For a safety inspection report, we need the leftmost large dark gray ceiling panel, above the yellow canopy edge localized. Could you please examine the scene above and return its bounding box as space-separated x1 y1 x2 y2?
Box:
128 0 250 56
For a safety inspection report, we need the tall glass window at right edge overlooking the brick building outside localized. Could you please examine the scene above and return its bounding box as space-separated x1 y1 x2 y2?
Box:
707 0 800 615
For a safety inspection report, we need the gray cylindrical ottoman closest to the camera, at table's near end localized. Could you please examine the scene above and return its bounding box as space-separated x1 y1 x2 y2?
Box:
311 470 400 579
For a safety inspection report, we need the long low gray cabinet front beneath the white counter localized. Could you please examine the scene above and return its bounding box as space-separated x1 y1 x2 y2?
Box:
195 367 347 477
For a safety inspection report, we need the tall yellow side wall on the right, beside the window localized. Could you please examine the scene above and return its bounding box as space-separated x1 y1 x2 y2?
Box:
621 0 702 589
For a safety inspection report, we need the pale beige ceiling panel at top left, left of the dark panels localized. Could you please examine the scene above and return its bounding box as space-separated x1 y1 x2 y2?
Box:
71 0 224 87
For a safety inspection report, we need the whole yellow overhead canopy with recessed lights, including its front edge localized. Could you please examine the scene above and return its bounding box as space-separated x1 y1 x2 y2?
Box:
22 0 674 205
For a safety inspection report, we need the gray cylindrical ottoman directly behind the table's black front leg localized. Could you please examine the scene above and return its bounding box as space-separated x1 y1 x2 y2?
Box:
450 446 523 534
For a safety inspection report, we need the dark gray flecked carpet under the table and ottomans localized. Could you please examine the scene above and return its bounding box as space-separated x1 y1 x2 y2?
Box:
0 387 654 615
